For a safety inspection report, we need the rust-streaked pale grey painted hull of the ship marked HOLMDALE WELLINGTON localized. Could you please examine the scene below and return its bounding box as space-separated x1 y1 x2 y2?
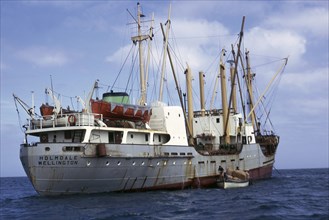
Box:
21 140 274 195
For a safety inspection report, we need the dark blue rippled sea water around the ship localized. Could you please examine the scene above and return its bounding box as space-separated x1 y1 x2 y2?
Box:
0 168 329 220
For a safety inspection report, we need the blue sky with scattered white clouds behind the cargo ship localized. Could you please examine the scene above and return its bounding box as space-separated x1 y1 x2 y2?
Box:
0 1 329 176
